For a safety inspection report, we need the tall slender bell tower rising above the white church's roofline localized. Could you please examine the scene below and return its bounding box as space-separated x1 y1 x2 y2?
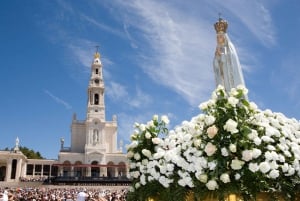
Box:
86 50 105 122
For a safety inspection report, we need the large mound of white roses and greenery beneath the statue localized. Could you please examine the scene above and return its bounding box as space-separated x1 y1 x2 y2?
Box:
127 86 300 201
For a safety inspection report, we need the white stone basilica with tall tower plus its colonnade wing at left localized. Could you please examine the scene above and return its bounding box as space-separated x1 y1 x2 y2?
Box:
0 51 128 182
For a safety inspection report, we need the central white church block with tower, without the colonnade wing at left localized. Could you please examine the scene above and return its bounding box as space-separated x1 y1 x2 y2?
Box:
58 52 127 177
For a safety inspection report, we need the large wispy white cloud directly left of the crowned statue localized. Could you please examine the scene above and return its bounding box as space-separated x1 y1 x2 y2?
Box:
112 1 215 105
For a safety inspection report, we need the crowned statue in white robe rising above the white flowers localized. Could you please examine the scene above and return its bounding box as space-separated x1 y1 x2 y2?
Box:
213 18 245 92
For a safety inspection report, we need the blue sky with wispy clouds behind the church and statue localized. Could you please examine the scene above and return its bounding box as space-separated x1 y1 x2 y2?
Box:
0 0 300 159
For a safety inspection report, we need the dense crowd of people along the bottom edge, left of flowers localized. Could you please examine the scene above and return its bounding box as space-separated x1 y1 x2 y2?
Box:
0 187 128 201
